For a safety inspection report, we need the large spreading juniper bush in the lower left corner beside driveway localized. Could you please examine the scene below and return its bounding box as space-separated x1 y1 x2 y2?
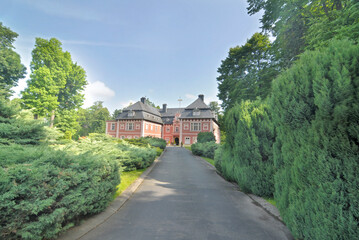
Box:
0 145 120 239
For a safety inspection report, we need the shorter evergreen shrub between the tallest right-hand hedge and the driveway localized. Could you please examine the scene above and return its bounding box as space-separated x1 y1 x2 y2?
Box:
215 100 274 196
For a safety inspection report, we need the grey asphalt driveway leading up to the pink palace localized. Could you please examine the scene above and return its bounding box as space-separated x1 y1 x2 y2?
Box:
81 147 293 240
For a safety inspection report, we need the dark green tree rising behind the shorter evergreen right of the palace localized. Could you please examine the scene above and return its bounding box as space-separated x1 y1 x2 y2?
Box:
217 33 277 109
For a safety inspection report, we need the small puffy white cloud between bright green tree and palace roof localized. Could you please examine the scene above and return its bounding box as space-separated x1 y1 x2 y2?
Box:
83 81 116 108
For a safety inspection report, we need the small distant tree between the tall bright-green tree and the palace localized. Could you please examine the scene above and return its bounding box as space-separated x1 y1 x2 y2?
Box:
76 101 111 137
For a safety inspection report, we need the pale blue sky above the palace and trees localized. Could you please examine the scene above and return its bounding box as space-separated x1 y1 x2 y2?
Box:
0 0 261 113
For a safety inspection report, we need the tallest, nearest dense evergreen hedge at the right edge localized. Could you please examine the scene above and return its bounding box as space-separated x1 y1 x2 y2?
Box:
271 41 359 239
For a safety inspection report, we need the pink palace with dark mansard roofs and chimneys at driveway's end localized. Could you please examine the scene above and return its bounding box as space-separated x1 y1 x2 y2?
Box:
106 94 220 145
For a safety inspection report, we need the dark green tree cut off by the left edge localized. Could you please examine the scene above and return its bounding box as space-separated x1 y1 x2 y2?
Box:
0 22 26 98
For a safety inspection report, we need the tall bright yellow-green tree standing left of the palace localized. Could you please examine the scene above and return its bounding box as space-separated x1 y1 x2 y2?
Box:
22 38 87 132
